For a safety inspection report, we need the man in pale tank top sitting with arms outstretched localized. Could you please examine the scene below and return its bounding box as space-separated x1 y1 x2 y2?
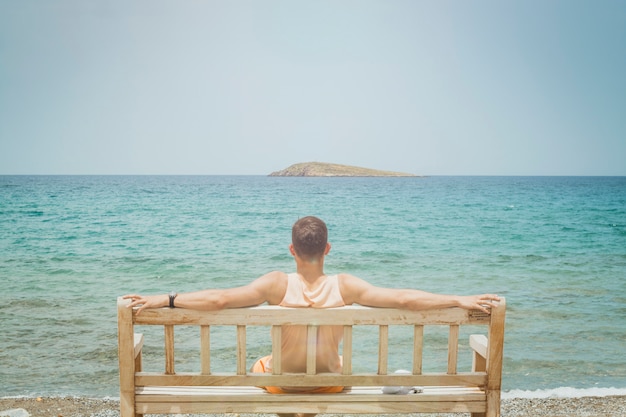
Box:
124 216 499 393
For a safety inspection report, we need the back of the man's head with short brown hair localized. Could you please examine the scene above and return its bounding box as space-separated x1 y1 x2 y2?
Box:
291 216 328 260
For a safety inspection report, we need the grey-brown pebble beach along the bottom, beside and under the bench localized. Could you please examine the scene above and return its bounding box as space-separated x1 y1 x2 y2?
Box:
0 396 626 417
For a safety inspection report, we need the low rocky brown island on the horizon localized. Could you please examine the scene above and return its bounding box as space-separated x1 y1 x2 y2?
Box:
269 162 416 177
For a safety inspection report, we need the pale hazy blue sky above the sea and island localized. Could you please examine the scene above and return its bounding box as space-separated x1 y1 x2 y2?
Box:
0 0 626 176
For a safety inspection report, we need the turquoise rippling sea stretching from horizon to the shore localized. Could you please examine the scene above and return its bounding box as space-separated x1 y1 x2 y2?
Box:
0 176 626 397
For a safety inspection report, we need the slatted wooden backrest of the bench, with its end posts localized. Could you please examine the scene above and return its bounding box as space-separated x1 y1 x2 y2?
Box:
118 298 505 395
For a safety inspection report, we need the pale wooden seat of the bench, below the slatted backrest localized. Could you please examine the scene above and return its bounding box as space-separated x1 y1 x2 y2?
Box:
135 386 486 414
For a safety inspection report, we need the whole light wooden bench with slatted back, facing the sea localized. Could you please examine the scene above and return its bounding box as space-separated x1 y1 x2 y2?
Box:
117 298 505 417
